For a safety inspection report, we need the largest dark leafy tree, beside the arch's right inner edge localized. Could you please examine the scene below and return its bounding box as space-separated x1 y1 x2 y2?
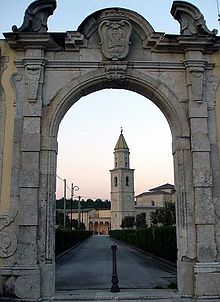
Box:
150 201 176 225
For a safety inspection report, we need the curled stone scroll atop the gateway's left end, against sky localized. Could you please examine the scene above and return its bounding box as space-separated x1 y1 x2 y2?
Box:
12 0 57 32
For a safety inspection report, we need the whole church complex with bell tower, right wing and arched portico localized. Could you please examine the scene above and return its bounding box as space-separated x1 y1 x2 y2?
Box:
64 130 176 231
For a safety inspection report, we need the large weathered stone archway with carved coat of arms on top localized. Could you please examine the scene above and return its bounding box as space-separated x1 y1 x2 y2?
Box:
0 0 220 300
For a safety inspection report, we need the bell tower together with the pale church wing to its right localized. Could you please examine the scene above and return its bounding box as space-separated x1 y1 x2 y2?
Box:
110 130 176 230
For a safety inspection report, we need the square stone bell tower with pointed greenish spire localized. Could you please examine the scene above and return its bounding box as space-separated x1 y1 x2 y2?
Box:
110 129 134 230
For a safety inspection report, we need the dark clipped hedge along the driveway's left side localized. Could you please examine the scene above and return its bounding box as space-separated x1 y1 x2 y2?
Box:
55 229 92 256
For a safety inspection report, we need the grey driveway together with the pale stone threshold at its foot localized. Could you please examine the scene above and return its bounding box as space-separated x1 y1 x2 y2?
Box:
54 236 220 302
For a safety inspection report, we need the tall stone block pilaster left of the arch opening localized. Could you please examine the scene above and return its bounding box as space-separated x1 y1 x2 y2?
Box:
13 47 45 299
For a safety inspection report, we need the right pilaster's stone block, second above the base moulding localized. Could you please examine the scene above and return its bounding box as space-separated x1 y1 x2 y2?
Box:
195 188 215 224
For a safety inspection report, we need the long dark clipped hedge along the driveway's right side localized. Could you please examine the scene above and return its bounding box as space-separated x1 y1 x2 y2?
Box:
109 226 177 262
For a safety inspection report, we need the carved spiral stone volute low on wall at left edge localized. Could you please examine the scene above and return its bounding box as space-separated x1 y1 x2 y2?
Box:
0 214 17 258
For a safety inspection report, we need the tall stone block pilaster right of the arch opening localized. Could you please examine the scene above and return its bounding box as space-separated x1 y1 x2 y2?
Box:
185 50 220 296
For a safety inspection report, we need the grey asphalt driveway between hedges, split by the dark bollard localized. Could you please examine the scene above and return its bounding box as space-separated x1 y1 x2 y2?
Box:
56 236 175 290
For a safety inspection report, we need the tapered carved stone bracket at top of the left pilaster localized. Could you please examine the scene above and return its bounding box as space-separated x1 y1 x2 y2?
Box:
25 65 42 102
